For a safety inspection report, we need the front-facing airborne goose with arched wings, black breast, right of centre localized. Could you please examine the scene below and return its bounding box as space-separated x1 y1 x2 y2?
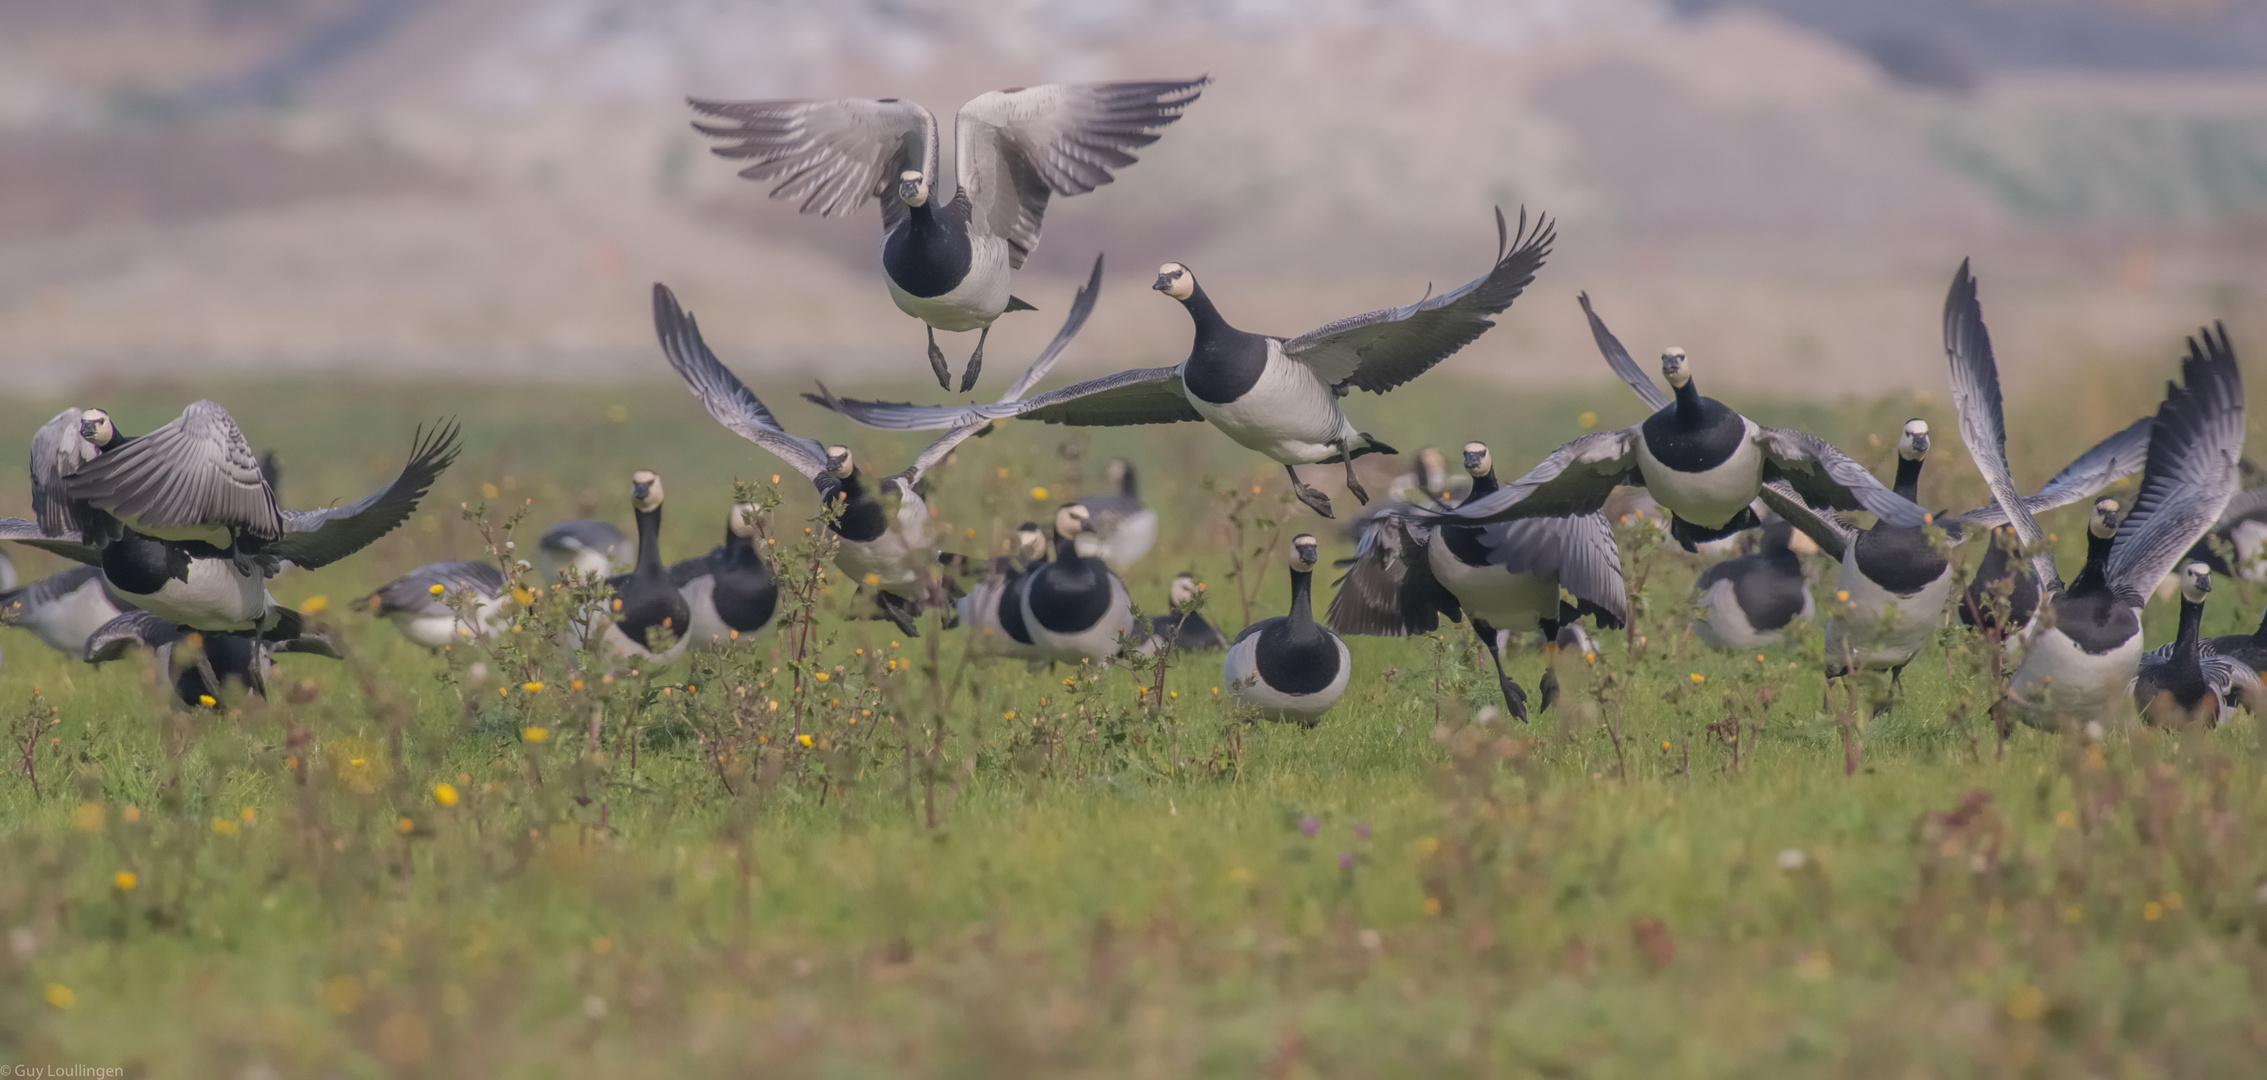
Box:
1419 295 1927 551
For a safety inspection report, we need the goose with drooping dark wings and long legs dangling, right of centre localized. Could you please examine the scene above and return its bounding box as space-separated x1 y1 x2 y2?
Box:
1328 442 1630 719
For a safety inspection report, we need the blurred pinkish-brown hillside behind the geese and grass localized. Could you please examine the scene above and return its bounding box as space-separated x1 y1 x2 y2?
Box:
0 0 2267 395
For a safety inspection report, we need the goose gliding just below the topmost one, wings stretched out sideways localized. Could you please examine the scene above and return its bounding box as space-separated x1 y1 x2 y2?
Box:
805 211 1555 517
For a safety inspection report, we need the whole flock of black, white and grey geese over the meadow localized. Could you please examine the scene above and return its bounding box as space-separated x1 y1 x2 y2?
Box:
0 77 2267 726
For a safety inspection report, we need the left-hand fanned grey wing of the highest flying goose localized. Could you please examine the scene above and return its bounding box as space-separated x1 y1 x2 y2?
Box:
685 98 950 227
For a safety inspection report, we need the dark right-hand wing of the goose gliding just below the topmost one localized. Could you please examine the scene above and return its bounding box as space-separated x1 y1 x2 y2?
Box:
1283 209 1557 395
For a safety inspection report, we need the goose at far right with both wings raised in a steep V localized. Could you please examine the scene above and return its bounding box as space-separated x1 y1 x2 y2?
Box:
1945 263 2244 728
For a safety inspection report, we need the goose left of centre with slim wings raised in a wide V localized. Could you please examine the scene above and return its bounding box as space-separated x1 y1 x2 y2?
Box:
653 256 1102 635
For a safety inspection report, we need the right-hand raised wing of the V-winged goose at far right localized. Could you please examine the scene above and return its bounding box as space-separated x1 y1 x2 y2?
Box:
2106 324 2244 606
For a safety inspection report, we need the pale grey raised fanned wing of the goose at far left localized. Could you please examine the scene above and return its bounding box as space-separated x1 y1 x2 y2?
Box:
61 402 283 538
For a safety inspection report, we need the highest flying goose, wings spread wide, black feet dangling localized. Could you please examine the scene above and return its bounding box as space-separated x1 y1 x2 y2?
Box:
691 77 1211 393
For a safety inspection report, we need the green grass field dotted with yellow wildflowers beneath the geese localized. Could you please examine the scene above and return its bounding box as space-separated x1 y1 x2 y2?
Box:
0 369 2267 1078
